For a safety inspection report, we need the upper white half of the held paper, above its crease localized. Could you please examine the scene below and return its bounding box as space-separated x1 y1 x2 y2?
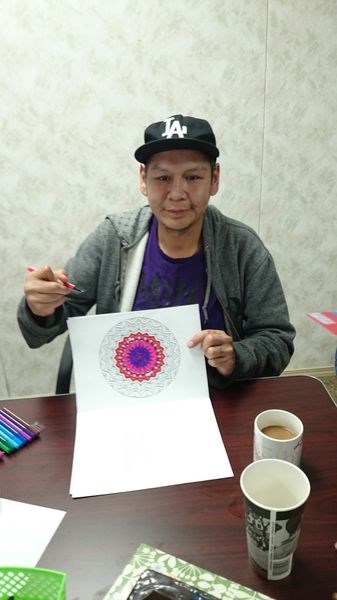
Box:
68 305 208 412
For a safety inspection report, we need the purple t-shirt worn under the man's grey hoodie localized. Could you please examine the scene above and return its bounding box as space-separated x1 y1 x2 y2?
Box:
132 217 224 329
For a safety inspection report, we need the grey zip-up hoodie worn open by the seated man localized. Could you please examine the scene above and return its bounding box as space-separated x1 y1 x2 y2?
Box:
18 206 295 388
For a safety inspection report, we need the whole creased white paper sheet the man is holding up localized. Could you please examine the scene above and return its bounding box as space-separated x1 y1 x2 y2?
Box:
68 305 233 497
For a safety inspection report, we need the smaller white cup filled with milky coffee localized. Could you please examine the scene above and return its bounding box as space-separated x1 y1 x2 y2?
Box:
253 409 303 466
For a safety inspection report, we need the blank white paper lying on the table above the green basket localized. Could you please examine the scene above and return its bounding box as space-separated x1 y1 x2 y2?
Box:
0 498 66 567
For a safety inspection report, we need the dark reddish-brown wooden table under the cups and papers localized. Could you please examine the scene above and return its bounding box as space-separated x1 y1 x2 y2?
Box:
0 376 337 600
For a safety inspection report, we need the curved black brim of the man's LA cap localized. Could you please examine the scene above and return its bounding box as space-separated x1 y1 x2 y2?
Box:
135 138 219 164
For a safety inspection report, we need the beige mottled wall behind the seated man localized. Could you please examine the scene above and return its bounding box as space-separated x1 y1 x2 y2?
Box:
0 0 337 397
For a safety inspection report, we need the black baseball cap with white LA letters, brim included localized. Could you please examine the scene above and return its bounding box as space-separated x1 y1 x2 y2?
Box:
135 115 219 164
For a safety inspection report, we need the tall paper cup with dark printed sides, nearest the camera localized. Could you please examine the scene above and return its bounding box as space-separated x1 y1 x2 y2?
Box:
240 459 310 580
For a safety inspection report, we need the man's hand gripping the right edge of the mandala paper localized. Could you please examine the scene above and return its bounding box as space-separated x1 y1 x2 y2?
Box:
187 329 236 377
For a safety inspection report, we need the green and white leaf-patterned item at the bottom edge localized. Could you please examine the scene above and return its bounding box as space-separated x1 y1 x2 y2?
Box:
104 544 272 600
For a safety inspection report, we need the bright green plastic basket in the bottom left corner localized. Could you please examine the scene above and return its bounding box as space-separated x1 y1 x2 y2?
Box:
0 567 66 600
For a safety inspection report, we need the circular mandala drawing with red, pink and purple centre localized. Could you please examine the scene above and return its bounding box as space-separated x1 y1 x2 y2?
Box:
99 317 180 397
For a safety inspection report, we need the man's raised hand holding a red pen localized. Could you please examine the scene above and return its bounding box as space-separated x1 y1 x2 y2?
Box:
24 266 70 317
